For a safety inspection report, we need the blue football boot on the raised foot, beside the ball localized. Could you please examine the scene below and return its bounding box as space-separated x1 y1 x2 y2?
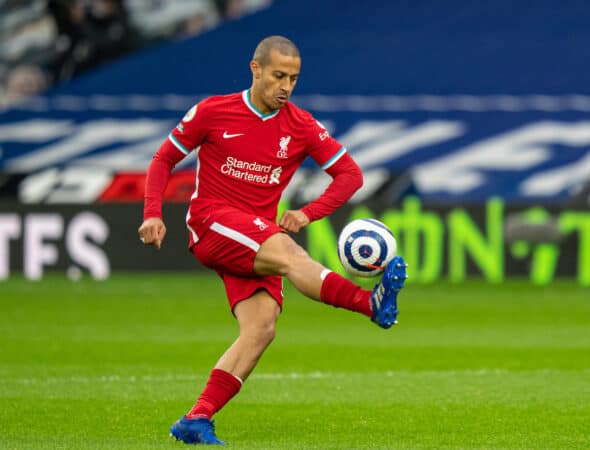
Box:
371 256 408 328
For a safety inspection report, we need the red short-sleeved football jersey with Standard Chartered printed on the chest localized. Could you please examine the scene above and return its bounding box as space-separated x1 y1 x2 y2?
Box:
168 89 346 221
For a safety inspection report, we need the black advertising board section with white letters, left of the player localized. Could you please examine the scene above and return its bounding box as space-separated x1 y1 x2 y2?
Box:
0 203 200 279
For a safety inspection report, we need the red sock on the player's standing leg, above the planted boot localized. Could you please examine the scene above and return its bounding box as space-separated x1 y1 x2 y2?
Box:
186 369 242 419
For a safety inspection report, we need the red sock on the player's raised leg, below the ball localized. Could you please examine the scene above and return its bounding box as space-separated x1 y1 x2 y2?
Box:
320 272 372 317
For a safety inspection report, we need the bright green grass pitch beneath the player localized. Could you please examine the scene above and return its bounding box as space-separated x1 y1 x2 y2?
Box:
0 274 590 449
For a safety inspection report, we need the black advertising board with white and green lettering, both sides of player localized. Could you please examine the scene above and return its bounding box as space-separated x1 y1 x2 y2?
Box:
0 197 590 286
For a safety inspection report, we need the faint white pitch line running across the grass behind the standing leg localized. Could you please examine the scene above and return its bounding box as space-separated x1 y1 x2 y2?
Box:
0 368 590 385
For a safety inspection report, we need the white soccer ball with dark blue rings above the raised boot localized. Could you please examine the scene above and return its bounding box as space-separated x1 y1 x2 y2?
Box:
338 219 397 277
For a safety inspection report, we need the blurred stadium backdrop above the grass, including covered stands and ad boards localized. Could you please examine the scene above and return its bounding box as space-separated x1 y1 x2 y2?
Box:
0 0 590 285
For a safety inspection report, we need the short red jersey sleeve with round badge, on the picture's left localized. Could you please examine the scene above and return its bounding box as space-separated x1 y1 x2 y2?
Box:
168 99 211 155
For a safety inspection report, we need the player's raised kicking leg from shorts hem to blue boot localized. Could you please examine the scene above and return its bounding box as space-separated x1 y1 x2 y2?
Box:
254 233 407 328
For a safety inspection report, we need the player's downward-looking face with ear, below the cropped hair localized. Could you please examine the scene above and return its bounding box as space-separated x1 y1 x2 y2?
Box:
250 50 301 114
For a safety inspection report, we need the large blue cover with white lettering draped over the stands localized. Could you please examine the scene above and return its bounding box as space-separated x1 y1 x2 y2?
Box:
0 0 590 203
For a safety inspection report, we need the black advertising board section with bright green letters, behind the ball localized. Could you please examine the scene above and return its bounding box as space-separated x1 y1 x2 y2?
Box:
306 197 590 286
